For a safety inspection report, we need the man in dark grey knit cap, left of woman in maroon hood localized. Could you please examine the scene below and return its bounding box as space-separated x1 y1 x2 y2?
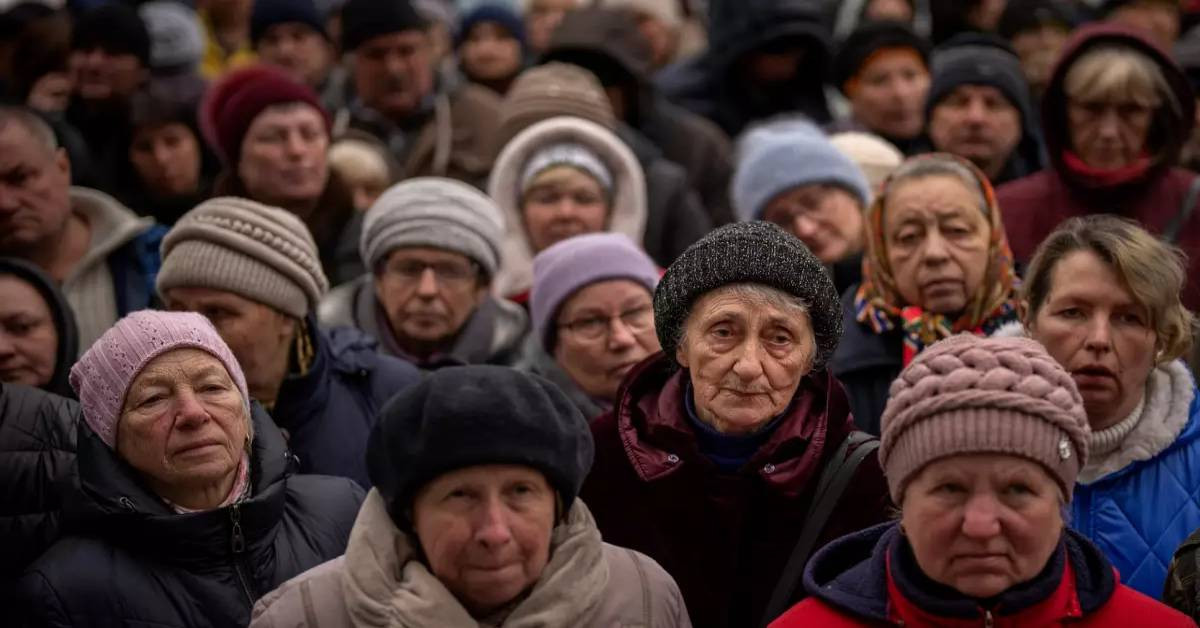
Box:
925 35 1043 185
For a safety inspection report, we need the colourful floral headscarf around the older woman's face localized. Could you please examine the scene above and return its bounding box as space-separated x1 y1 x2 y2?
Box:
854 152 1020 365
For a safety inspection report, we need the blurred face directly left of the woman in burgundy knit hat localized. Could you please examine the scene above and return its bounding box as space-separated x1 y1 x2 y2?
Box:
130 122 200 198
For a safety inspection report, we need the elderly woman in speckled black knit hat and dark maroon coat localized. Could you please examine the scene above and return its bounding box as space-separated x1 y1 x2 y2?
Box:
582 222 888 627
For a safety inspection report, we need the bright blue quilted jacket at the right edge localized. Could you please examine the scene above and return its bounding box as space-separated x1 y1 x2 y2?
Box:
1070 384 1200 599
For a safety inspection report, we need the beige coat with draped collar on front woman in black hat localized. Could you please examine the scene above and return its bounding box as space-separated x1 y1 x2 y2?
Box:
251 490 691 628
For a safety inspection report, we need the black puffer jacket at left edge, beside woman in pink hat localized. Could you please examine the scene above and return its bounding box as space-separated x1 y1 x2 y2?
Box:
0 384 79 588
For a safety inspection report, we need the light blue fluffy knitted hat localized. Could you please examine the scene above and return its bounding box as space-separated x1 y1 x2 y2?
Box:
730 120 871 220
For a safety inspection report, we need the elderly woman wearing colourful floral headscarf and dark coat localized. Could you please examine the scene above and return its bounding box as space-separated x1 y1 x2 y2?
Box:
830 154 1016 433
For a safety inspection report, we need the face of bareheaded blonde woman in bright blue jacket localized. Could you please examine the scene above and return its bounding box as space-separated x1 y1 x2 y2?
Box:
1028 251 1158 430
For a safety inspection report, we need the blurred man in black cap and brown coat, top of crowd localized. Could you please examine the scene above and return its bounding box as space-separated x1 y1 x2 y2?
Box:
335 0 499 185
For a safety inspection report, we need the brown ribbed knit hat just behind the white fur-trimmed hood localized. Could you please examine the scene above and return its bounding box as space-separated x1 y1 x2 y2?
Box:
497 62 617 151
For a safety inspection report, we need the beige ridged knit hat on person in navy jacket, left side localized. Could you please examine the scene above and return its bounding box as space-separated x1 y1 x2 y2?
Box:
157 197 329 318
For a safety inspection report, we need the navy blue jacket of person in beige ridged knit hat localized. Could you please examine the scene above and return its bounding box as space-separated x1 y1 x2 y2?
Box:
271 316 420 488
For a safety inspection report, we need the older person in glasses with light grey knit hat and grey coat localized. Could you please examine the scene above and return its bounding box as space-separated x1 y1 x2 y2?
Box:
320 177 528 370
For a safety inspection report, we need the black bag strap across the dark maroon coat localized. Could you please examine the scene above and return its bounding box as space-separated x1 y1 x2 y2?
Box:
762 431 880 627
